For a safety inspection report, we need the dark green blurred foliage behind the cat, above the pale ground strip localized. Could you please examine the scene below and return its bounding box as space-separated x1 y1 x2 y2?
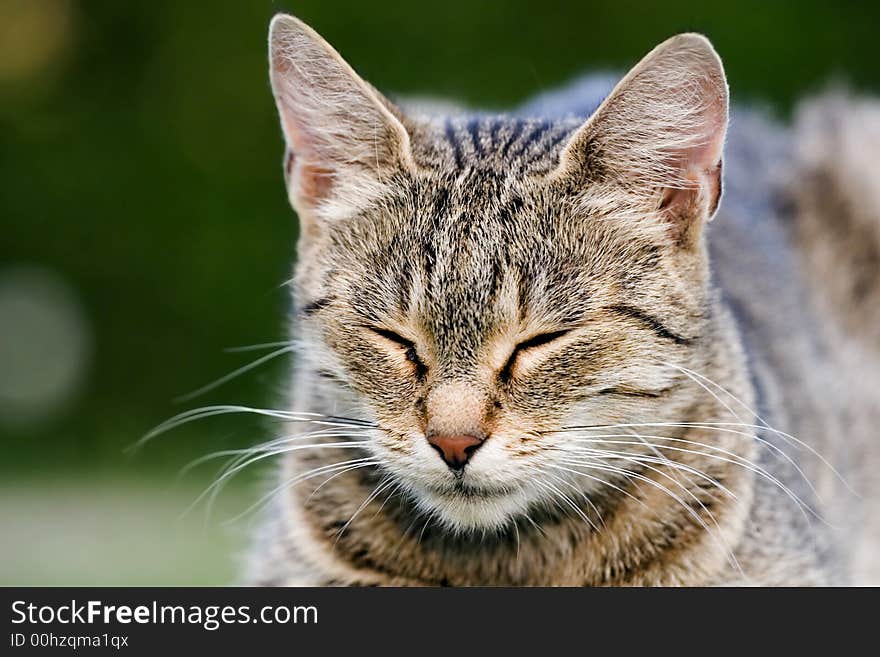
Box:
0 0 880 472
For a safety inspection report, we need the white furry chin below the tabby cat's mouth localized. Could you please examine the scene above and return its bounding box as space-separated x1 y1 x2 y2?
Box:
414 488 536 533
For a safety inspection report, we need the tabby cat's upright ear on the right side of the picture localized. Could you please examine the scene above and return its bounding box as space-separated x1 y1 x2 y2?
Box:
556 34 728 246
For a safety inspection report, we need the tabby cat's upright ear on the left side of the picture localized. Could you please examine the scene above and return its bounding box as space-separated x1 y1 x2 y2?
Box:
269 14 412 222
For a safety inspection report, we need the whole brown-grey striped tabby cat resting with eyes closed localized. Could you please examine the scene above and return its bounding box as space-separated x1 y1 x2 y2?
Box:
248 15 880 586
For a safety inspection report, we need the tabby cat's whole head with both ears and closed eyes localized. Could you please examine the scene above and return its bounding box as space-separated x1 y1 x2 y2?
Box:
270 16 727 530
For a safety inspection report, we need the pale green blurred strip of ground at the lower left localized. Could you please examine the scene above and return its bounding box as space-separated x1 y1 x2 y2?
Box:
0 474 256 586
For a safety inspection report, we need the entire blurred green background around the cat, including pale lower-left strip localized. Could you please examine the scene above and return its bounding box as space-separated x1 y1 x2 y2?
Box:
0 0 880 584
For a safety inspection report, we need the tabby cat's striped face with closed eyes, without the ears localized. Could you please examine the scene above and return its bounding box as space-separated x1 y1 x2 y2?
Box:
299 172 700 527
